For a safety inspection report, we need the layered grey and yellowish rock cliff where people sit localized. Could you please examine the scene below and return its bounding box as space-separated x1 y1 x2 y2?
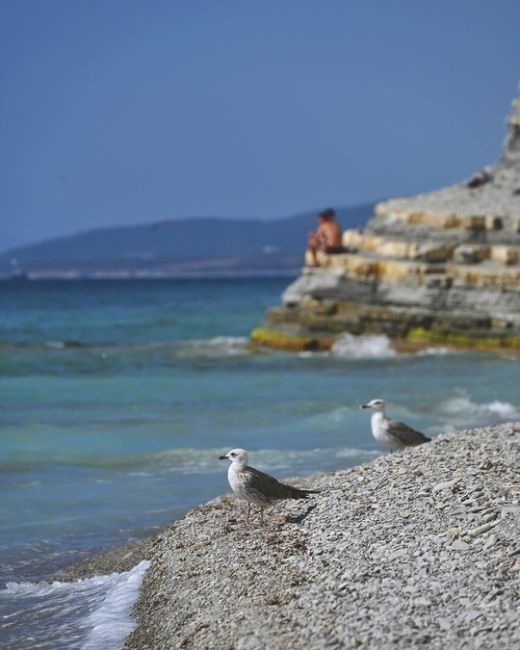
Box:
252 90 520 349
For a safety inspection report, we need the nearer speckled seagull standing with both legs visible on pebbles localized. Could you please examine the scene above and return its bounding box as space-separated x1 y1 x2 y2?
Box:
219 449 318 525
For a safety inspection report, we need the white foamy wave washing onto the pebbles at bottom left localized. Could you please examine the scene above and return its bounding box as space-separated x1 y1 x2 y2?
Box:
4 560 150 650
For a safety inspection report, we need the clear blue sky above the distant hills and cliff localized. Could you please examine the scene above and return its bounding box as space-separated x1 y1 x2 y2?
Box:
0 0 520 250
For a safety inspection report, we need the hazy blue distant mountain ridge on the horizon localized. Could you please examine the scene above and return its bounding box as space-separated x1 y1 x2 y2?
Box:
0 203 374 276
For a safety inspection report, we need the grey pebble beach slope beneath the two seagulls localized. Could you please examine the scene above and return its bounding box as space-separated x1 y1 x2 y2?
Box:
121 423 520 650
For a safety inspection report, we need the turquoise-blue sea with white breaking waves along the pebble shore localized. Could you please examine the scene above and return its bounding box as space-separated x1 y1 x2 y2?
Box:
0 278 520 650
